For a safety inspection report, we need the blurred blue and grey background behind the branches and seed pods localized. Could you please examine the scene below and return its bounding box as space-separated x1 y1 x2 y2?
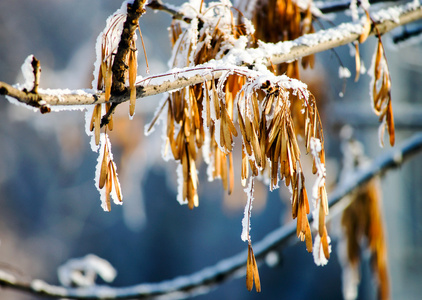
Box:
0 0 422 300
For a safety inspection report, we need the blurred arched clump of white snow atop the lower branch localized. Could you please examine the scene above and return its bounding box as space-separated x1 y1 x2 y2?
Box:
58 254 117 287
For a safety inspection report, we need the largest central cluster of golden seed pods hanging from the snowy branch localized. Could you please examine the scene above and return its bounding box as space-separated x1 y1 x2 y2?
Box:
143 0 330 290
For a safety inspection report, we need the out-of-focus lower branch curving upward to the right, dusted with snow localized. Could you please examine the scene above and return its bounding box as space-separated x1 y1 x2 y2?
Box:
0 134 422 299
